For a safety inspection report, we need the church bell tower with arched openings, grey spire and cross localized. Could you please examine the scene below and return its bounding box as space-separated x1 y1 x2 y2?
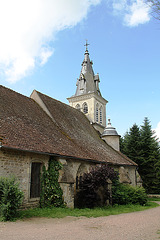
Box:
67 40 108 134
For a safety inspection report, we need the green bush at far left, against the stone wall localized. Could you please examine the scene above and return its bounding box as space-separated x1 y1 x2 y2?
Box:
0 177 23 221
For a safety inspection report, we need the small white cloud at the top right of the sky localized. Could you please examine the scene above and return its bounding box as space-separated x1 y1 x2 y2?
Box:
109 0 150 27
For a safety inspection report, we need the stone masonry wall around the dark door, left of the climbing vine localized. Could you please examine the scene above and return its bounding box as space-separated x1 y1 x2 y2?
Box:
0 150 49 205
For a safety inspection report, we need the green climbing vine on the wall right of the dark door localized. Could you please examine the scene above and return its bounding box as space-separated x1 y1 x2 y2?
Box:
40 157 63 207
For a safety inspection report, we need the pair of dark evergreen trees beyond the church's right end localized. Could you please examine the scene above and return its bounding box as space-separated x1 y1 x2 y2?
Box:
121 118 160 193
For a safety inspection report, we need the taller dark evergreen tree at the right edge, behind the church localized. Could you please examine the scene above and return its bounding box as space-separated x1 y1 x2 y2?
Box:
139 118 160 193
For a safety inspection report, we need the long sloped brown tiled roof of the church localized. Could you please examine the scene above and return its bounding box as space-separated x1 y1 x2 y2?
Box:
0 86 136 165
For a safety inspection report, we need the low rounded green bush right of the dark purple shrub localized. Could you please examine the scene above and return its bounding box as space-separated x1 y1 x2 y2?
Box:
112 181 147 205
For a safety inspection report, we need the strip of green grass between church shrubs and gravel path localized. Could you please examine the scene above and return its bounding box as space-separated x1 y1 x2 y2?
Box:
0 199 159 221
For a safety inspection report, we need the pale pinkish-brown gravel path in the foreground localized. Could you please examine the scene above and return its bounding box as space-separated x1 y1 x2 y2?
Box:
0 202 160 240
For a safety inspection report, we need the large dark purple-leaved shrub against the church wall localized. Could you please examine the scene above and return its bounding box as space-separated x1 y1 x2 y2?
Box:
76 164 118 208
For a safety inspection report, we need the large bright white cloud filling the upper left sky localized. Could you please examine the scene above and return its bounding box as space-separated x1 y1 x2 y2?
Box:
0 0 101 82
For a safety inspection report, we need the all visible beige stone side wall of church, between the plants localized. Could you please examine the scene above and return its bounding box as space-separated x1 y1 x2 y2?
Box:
0 150 136 208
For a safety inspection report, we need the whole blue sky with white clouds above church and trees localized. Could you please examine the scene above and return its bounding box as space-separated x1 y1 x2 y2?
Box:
0 0 160 138
